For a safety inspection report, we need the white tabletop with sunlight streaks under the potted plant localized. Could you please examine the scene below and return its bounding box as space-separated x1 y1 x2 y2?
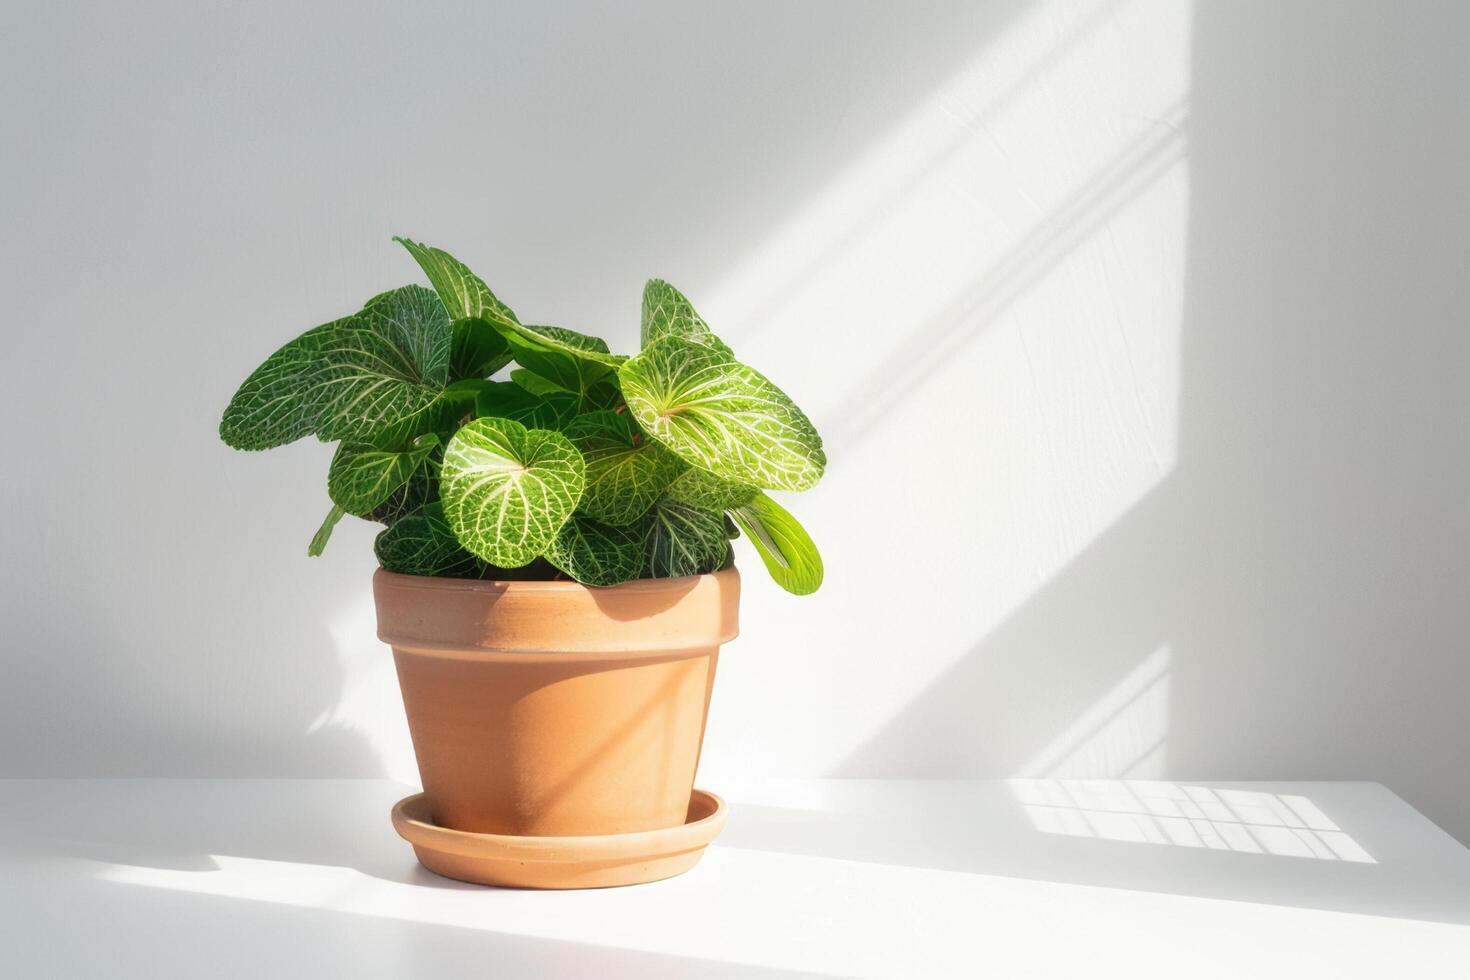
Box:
0 780 1470 980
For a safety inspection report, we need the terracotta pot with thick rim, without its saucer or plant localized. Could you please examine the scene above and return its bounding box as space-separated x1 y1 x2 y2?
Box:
373 569 739 836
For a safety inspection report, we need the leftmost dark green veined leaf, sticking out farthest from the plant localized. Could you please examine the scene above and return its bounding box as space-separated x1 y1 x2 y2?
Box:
219 317 353 450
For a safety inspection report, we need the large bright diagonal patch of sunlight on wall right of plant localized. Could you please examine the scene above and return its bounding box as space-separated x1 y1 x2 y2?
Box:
701 0 1191 776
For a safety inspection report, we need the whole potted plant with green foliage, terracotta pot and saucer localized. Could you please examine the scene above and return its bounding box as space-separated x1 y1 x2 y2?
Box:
219 238 826 887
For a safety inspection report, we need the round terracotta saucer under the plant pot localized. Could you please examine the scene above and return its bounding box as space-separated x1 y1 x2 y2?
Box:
392 789 726 887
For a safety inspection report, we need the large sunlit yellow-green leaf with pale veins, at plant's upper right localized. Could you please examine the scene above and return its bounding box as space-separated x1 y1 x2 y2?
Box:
617 336 826 491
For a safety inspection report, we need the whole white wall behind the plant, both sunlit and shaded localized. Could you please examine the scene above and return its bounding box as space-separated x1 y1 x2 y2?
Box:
0 0 1470 839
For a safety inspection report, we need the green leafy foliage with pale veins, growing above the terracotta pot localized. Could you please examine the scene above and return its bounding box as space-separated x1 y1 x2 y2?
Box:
219 238 826 595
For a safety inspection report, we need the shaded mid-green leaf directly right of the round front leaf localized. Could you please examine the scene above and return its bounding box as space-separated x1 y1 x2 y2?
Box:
566 411 684 526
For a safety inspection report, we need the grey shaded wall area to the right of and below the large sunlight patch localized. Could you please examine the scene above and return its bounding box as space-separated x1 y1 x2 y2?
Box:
836 3 1470 839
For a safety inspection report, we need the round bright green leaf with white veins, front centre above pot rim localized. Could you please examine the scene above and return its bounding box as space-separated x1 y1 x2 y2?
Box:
440 419 585 569
